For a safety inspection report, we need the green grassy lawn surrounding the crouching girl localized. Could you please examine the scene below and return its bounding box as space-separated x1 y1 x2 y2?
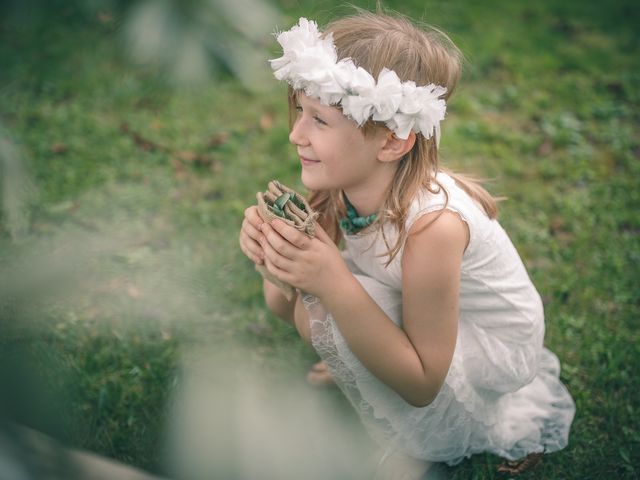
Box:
0 0 640 479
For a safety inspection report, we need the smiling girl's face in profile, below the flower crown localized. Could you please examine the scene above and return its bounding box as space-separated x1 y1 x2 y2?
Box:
289 93 386 194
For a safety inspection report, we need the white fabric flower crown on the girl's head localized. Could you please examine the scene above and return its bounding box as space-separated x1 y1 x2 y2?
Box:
270 18 447 144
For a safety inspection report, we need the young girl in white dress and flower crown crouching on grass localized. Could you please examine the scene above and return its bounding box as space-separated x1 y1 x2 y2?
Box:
240 12 575 478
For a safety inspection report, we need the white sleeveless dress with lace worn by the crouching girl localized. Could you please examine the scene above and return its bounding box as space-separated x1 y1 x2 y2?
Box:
304 173 575 465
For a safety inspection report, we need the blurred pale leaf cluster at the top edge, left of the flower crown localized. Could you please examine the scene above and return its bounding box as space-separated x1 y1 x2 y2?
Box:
124 0 280 90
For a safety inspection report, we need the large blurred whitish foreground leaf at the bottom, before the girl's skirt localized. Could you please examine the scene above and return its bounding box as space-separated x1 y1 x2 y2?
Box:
167 351 372 480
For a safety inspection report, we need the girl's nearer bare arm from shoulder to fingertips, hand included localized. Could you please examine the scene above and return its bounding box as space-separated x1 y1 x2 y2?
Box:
262 211 468 406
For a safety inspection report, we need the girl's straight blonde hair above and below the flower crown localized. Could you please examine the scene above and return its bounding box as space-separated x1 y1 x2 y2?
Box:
289 10 497 263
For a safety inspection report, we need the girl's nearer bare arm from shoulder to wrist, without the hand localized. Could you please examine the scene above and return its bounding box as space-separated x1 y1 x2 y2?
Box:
306 211 468 406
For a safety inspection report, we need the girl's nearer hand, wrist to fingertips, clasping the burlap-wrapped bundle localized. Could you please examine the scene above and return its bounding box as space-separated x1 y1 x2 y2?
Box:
261 220 351 299
